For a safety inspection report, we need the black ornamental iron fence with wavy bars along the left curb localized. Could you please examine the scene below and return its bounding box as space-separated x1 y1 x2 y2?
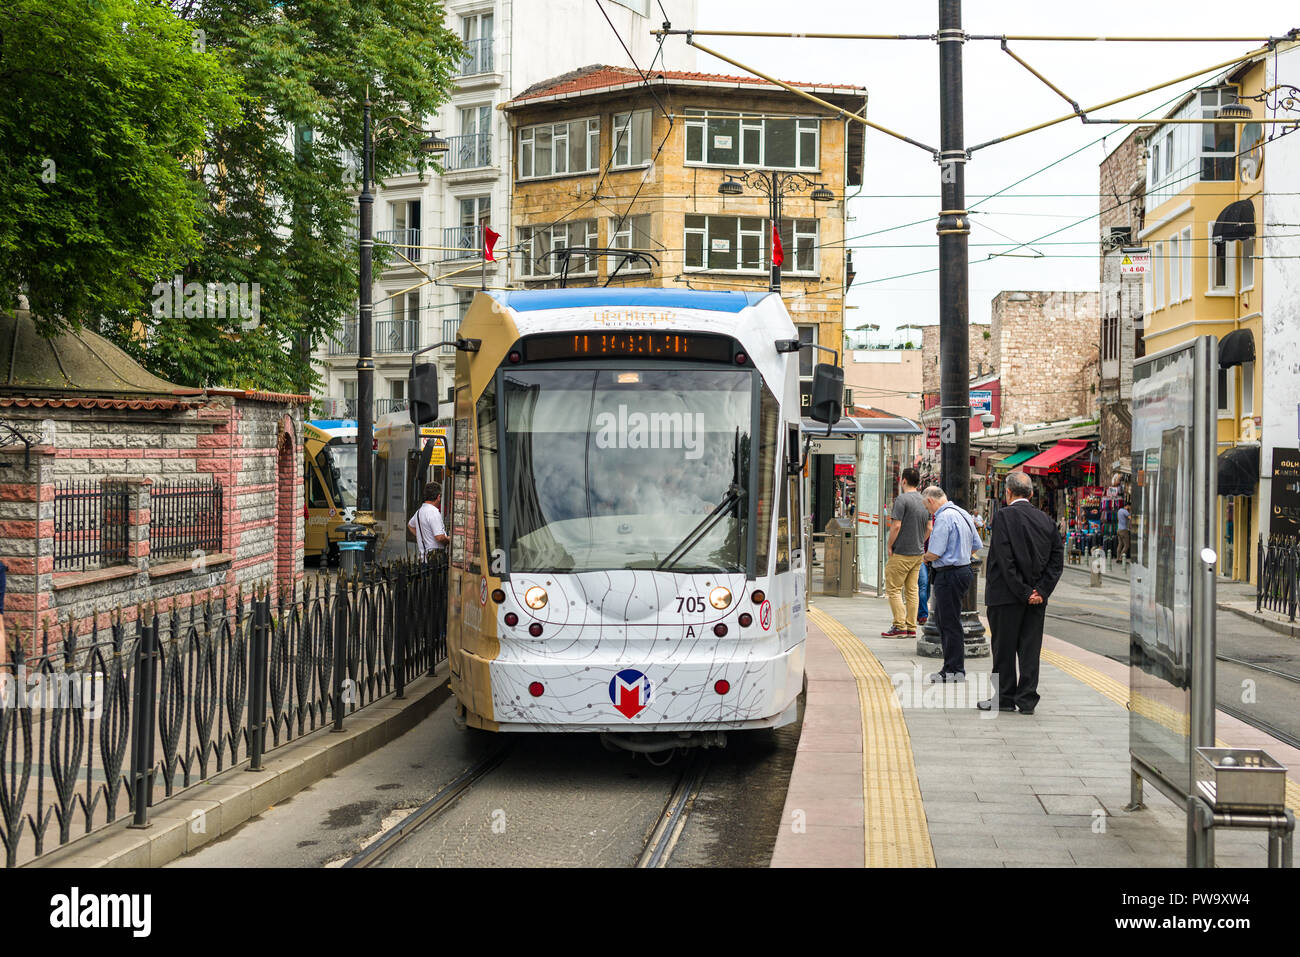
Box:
0 559 447 867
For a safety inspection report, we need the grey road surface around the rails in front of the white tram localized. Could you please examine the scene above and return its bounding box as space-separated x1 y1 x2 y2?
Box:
170 686 800 867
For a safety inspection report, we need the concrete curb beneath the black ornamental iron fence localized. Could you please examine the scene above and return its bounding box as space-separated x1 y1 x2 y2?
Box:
22 664 451 867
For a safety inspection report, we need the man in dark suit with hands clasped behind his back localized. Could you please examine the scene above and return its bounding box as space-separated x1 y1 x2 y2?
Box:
979 472 1065 714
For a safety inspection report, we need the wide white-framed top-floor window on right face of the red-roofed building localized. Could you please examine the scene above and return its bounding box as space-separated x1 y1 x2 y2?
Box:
686 111 820 169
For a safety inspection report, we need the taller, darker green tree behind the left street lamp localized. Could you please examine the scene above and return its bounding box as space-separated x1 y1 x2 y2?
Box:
122 0 463 391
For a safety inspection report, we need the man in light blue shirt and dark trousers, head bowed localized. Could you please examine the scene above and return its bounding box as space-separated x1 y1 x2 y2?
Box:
922 485 980 681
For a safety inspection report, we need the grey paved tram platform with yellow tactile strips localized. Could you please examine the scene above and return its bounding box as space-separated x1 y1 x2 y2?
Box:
772 593 1300 867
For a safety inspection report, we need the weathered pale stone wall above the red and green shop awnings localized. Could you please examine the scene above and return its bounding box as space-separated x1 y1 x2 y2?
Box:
989 291 1100 425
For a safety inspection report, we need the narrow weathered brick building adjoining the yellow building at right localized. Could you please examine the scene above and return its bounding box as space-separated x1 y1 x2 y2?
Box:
1097 126 1152 471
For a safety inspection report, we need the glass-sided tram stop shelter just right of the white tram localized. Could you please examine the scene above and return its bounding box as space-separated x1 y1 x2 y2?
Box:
802 408 922 596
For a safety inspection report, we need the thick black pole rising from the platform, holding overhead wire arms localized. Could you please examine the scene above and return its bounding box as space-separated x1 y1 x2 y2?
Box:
935 0 989 657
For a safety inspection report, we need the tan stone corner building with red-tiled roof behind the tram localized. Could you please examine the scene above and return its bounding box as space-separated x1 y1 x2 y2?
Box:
501 66 866 402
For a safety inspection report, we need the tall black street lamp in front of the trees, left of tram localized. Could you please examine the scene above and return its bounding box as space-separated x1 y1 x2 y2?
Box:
355 92 447 553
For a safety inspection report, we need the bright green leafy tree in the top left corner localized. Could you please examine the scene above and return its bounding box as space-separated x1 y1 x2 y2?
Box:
0 0 238 334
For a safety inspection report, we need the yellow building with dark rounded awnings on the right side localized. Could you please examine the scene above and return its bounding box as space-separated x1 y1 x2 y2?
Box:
1136 57 1268 581
